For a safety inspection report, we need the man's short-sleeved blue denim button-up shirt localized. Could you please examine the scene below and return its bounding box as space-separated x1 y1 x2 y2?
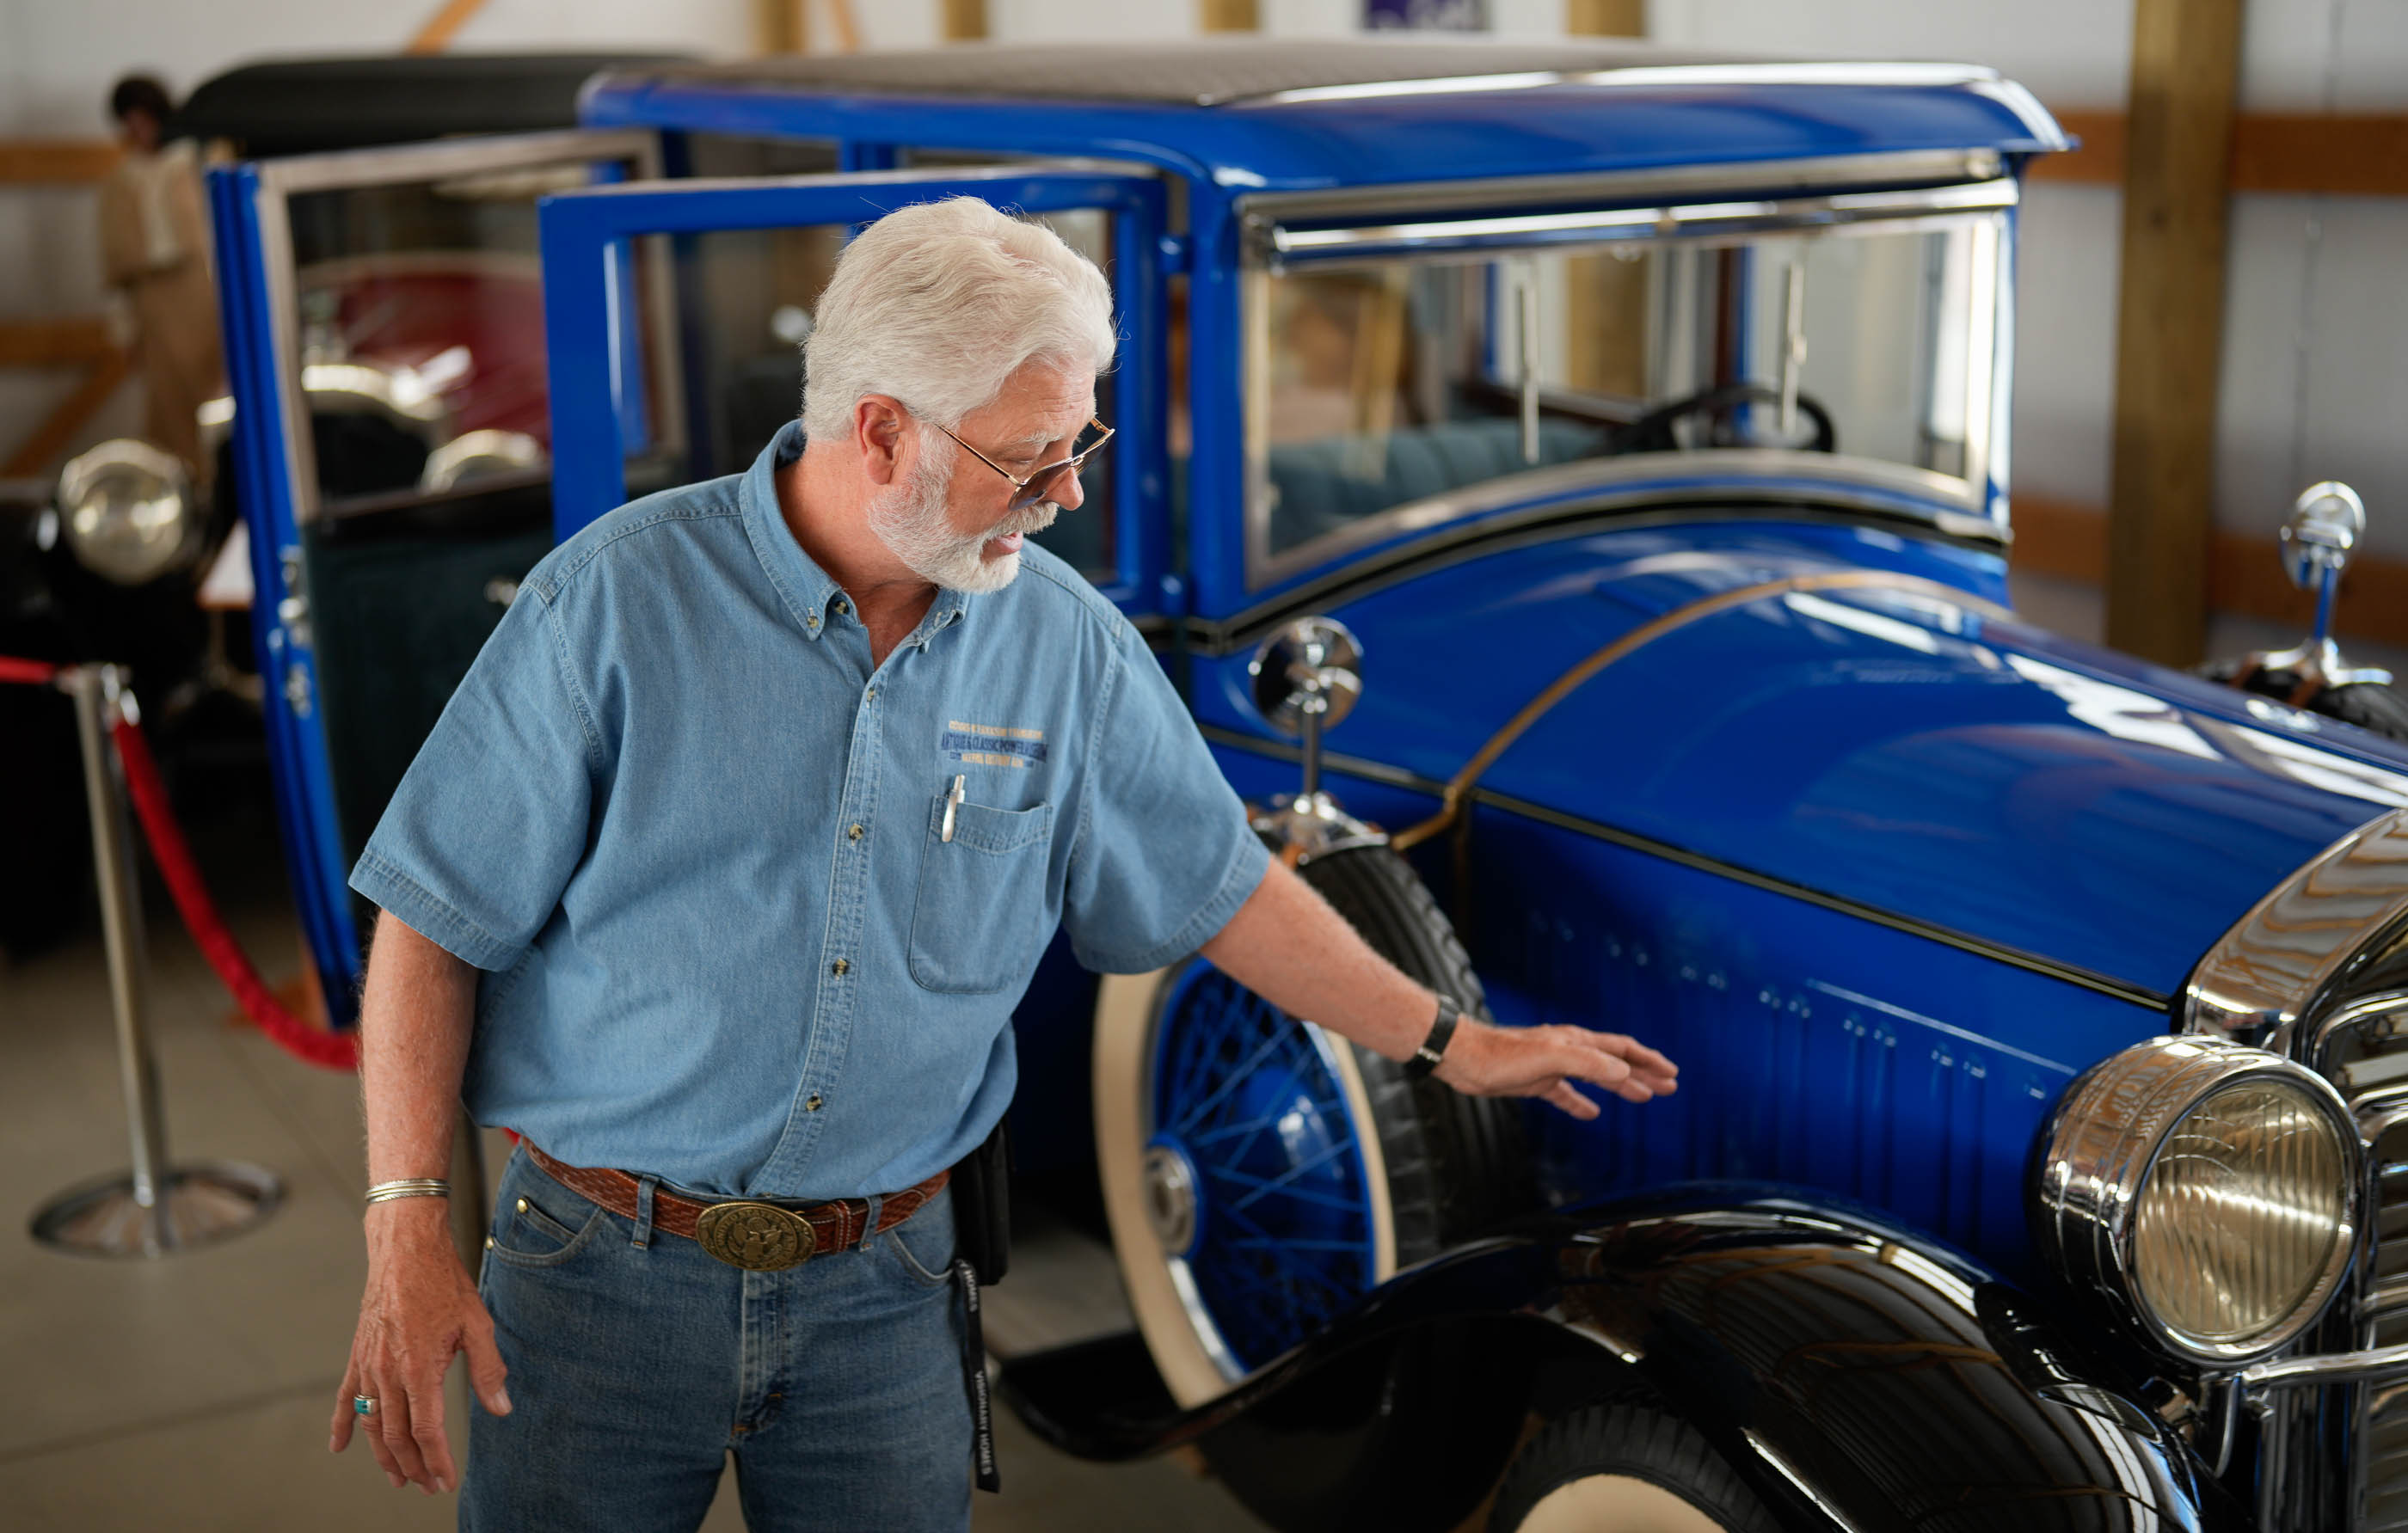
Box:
352 426 1267 1199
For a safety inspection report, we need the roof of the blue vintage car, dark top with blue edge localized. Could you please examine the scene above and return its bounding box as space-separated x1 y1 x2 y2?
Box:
583 39 2068 190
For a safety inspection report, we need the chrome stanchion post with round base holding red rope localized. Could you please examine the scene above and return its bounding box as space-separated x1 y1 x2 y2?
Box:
34 665 284 1256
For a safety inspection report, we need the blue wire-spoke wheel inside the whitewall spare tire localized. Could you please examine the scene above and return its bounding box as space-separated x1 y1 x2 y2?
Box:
1146 960 1394 1379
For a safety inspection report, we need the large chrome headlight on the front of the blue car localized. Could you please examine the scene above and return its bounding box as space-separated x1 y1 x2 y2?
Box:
2032 1037 2362 1364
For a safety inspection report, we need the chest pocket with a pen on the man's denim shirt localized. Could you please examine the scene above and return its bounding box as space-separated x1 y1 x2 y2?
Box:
910 794 1053 996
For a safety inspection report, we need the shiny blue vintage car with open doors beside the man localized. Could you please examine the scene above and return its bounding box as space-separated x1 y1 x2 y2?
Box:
214 41 2408 1530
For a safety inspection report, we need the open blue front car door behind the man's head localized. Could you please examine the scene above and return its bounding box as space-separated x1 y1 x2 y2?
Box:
542 162 1173 621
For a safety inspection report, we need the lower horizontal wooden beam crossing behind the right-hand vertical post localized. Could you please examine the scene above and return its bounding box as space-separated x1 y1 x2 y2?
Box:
2011 496 2408 645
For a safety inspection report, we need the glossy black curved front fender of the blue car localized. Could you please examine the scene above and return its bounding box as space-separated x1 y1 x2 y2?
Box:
1002 1189 2254 1533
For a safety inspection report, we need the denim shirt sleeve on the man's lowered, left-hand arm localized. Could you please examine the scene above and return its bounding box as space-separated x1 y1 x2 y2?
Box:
352 587 605 970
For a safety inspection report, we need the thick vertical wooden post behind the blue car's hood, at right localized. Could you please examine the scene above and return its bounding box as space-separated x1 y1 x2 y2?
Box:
2107 0 2242 665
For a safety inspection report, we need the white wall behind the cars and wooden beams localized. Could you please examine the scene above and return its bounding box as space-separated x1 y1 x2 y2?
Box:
0 0 2408 558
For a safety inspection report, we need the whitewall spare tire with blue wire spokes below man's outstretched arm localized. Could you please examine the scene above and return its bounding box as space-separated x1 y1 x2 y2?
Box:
1093 844 1534 1414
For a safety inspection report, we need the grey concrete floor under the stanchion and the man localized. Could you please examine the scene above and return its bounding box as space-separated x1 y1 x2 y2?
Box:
0 823 1259 1533
